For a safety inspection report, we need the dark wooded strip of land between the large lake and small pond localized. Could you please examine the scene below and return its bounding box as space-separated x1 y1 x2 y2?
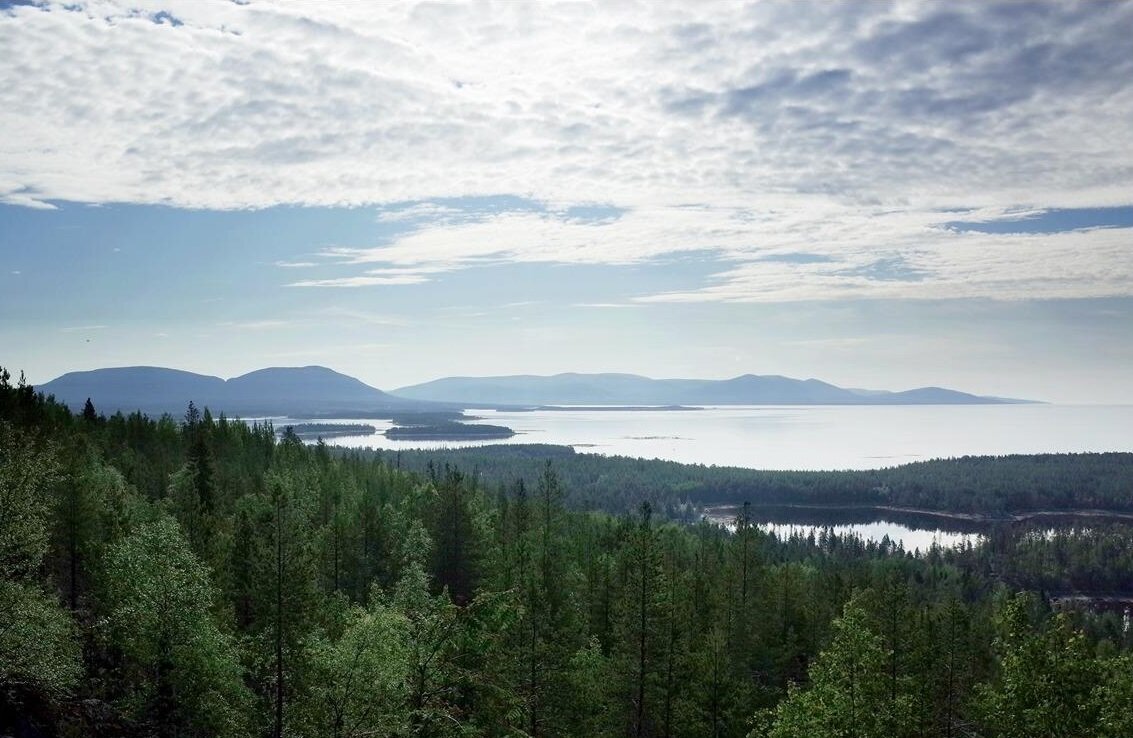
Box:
377 444 1133 517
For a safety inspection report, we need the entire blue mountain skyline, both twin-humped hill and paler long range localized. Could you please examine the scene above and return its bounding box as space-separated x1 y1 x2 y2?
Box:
37 366 1025 417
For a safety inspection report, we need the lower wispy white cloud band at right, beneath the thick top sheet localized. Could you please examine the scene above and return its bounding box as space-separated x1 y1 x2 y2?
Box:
278 197 1133 306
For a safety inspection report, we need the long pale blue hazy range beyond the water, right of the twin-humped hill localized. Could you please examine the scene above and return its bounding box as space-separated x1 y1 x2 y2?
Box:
393 374 1025 407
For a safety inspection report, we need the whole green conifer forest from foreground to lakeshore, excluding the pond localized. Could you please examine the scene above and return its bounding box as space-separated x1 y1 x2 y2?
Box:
0 370 1133 738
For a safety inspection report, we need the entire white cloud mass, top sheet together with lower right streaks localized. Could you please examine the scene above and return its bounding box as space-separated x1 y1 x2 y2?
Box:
0 0 1133 304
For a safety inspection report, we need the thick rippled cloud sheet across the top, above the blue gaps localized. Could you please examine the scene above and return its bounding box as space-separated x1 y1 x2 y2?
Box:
0 0 1133 210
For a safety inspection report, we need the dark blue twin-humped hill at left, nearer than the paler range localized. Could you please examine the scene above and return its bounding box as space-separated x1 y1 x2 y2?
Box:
36 366 436 417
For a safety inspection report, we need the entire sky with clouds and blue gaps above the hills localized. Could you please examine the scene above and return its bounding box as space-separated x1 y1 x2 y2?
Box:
0 0 1133 402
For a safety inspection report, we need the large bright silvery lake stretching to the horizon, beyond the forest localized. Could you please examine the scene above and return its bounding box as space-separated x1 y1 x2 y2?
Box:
310 405 1133 469
